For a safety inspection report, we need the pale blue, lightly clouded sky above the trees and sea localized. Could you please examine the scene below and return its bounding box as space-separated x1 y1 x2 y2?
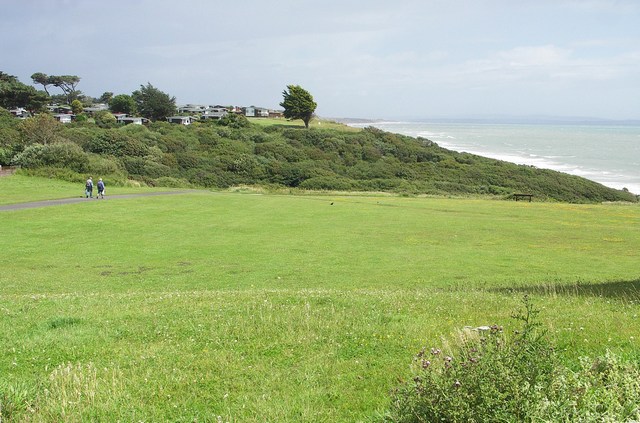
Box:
0 0 640 120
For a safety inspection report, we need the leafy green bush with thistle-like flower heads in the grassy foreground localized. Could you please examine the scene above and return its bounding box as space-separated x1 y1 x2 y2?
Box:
381 297 640 423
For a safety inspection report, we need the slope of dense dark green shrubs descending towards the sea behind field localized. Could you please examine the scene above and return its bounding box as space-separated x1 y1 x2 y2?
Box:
0 108 636 202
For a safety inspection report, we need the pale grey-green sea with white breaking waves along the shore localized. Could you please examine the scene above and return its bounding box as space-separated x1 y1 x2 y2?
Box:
348 121 640 194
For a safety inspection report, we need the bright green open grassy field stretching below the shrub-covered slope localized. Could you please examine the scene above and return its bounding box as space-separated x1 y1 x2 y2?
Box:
0 176 640 422
